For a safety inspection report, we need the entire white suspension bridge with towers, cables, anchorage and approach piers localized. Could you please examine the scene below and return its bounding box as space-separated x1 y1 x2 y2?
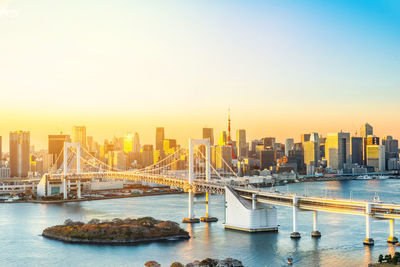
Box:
37 139 400 245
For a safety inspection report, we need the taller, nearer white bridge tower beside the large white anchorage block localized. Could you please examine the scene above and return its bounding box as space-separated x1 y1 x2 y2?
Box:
182 138 218 223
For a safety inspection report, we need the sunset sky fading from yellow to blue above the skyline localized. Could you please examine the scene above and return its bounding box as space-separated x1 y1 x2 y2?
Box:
0 0 400 150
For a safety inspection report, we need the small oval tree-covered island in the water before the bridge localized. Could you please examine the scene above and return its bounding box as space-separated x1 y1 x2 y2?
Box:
42 217 190 245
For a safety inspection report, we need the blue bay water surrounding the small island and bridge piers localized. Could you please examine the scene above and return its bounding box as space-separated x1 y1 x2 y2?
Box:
0 180 400 267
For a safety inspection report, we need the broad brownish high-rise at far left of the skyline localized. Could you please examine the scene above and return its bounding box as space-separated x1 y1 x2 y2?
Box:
10 131 30 177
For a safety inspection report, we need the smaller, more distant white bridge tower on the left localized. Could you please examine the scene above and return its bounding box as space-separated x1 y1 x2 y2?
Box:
62 142 81 199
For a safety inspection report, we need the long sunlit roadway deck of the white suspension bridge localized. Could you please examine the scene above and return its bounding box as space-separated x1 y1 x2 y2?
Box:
50 172 400 219
